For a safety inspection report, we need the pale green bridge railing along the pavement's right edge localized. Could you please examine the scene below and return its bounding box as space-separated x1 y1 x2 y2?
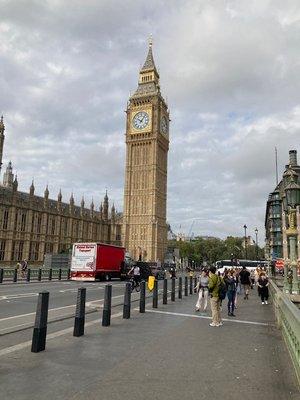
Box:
270 280 300 382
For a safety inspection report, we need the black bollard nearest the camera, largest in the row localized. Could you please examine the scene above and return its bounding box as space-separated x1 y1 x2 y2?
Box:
31 292 49 353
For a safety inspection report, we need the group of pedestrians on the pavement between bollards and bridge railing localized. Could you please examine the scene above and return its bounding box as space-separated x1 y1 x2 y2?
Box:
193 266 269 327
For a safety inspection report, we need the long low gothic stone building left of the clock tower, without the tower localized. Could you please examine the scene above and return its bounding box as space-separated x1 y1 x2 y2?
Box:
0 117 122 266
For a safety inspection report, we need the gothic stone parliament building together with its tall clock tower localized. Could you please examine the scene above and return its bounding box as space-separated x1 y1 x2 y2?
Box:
0 42 169 266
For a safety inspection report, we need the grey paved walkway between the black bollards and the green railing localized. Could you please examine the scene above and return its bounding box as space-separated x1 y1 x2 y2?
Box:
0 291 300 400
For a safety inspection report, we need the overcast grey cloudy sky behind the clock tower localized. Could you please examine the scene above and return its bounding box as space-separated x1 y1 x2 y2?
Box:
0 0 300 243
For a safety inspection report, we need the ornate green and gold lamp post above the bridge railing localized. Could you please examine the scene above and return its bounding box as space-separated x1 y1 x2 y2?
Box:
284 174 300 294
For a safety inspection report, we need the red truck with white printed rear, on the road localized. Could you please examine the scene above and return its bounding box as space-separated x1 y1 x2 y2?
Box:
70 243 125 281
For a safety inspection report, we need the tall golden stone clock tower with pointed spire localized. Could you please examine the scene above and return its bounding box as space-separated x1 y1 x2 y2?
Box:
123 41 169 261
